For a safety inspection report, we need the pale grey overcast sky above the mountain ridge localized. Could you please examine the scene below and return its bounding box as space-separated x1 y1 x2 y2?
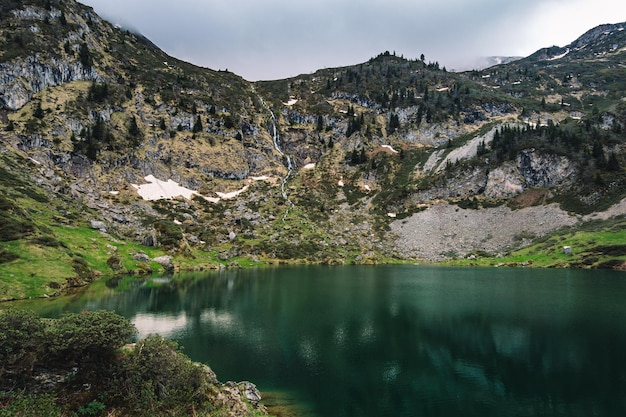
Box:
81 0 626 81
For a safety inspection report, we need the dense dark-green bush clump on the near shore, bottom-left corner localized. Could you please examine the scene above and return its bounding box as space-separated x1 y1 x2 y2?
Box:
0 309 233 417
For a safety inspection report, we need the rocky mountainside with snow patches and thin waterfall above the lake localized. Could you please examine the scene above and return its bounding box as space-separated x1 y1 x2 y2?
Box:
0 0 626 299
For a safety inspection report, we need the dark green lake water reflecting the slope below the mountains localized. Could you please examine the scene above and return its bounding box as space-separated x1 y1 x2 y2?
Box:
12 266 626 417
